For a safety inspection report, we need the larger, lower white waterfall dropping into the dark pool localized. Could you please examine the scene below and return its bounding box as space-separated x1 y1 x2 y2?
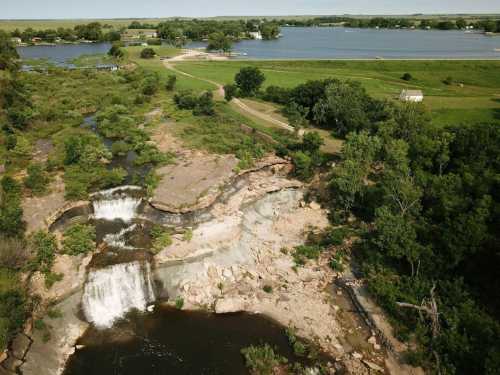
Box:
82 261 155 328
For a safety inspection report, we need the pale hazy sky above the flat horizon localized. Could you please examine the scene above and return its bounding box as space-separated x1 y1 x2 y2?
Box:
0 0 500 19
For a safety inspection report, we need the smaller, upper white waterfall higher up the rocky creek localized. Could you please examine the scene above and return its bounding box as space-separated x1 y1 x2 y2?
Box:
93 186 141 222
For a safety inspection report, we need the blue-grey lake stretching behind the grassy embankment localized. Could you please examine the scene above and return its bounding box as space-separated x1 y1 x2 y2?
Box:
18 27 500 65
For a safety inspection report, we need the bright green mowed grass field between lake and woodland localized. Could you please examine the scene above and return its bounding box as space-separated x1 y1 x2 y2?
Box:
175 60 500 125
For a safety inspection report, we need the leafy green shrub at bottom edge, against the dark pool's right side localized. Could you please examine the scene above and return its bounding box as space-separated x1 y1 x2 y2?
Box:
241 344 287 375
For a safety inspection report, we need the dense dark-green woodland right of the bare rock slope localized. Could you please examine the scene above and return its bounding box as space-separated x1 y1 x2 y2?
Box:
226 68 500 374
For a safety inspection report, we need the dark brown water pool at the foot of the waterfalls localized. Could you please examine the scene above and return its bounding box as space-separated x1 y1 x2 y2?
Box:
64 308 306 375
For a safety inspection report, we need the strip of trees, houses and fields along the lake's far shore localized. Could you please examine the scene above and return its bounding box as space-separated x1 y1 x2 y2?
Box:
0 15 500 52
